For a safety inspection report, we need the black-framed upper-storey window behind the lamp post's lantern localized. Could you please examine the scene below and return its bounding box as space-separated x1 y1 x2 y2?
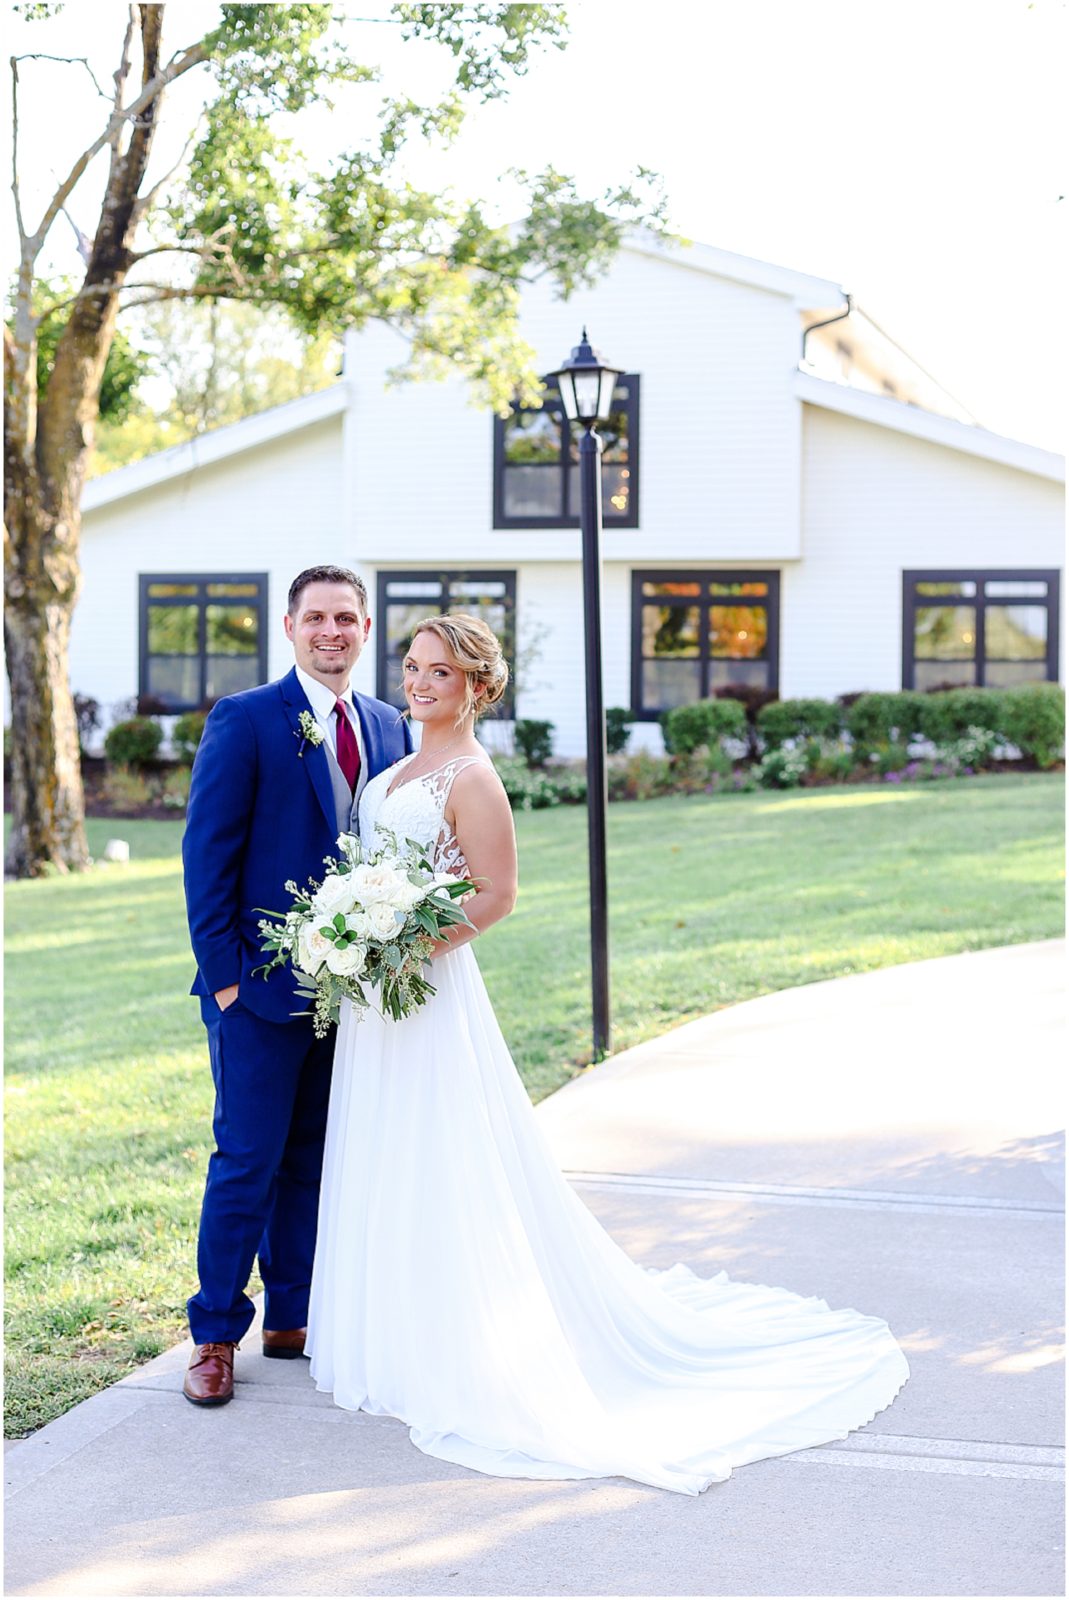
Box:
493 373 640 528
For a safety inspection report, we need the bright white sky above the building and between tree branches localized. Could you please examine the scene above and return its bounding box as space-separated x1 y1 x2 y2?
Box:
6 0 1069 450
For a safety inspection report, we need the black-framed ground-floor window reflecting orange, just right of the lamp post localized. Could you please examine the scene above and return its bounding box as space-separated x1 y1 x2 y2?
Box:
631 568 779 722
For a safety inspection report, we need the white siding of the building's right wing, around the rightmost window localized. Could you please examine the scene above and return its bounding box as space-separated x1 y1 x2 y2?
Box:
790 406 1064 699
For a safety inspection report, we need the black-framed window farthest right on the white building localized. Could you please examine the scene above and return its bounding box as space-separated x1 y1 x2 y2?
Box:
903 566 1059 690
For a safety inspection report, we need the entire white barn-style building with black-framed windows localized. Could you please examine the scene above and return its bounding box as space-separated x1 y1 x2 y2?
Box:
72 237 1064 755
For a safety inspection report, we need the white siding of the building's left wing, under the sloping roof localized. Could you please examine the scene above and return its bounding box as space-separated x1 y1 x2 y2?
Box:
70 418 342 709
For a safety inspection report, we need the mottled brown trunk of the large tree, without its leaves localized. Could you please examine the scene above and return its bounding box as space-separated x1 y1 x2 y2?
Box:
3 5 168 877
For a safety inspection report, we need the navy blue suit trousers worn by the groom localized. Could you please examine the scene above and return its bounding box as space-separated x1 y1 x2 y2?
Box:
189 998 334 1344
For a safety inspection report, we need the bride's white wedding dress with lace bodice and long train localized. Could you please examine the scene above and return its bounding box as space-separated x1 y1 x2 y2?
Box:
307 757 909 1494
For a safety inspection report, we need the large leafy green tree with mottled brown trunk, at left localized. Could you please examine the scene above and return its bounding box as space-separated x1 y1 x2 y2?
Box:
5 0 664 875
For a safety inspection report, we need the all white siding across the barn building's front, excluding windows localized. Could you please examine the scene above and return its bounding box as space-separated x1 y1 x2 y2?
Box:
33 238 1064 755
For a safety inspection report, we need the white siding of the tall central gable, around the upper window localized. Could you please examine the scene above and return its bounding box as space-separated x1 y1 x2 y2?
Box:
346 251 800 565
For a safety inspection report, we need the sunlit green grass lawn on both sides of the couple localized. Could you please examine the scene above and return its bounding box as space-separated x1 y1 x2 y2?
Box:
6 774 1064 1435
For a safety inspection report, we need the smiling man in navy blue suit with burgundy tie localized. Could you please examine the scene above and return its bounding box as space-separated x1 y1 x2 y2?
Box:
182 566 411 1405
